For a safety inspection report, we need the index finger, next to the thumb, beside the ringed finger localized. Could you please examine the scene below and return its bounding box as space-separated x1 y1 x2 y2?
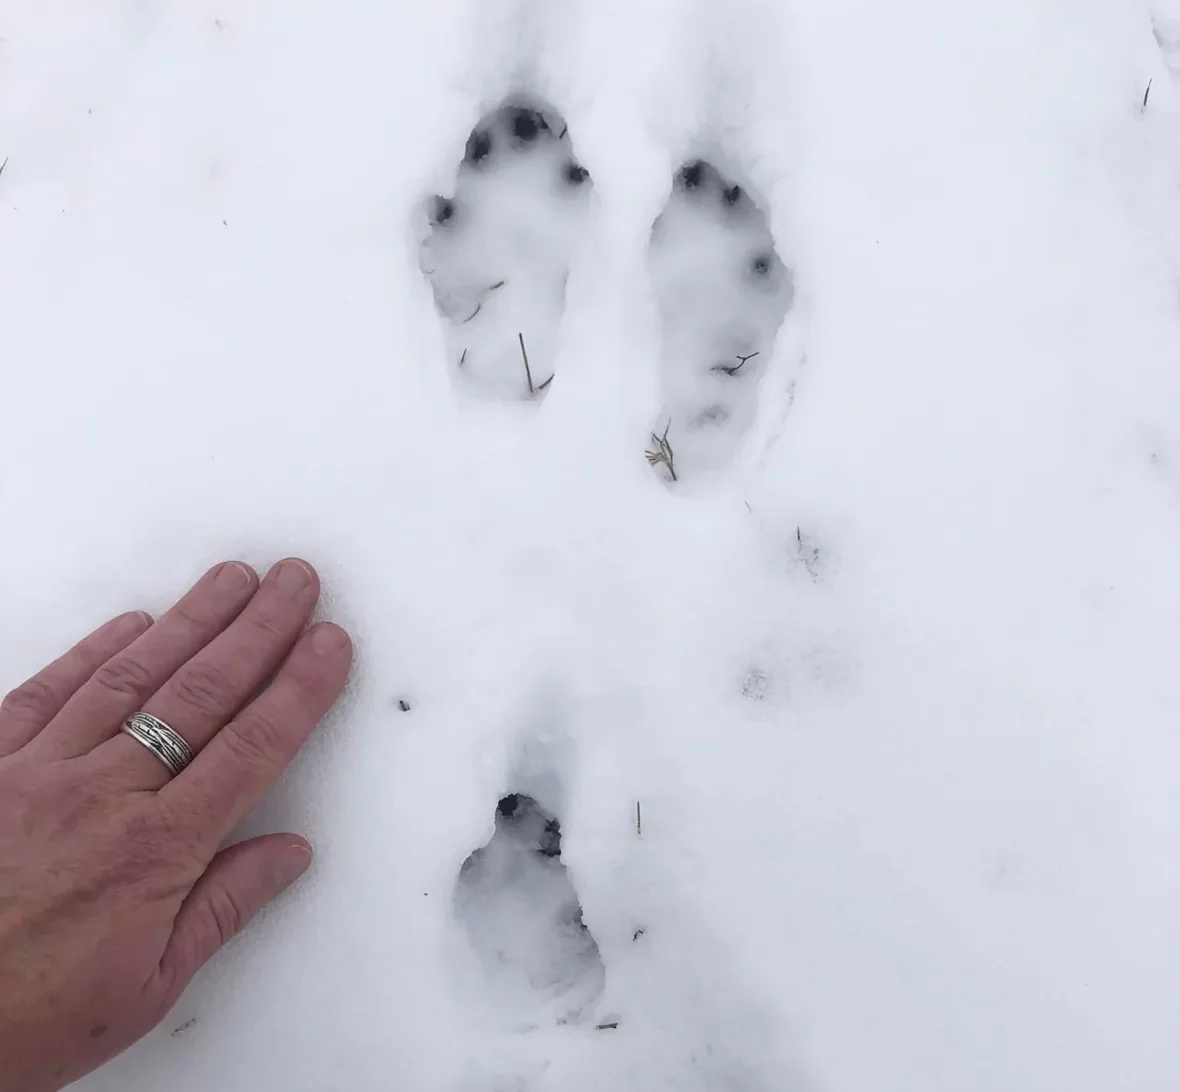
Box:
159 622 353 850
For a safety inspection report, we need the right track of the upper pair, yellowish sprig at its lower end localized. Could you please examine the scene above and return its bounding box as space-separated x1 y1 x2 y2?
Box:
648 159 794 480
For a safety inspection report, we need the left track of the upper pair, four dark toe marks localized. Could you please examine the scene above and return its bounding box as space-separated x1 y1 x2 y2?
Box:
420 99 591 399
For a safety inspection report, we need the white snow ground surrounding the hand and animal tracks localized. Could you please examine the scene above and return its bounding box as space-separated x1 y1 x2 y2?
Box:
0 0 1180 1092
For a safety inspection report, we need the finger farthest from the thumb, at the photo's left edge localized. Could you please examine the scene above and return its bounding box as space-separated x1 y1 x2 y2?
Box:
0 610 152 758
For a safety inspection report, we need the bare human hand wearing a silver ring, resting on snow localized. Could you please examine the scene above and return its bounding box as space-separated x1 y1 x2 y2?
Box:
0 560 352 1092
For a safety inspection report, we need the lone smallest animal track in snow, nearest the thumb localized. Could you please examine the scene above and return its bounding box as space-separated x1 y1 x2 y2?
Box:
454 792 605 1031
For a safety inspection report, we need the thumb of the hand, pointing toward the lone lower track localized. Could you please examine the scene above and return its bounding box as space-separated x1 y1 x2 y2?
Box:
160 835 312 995
